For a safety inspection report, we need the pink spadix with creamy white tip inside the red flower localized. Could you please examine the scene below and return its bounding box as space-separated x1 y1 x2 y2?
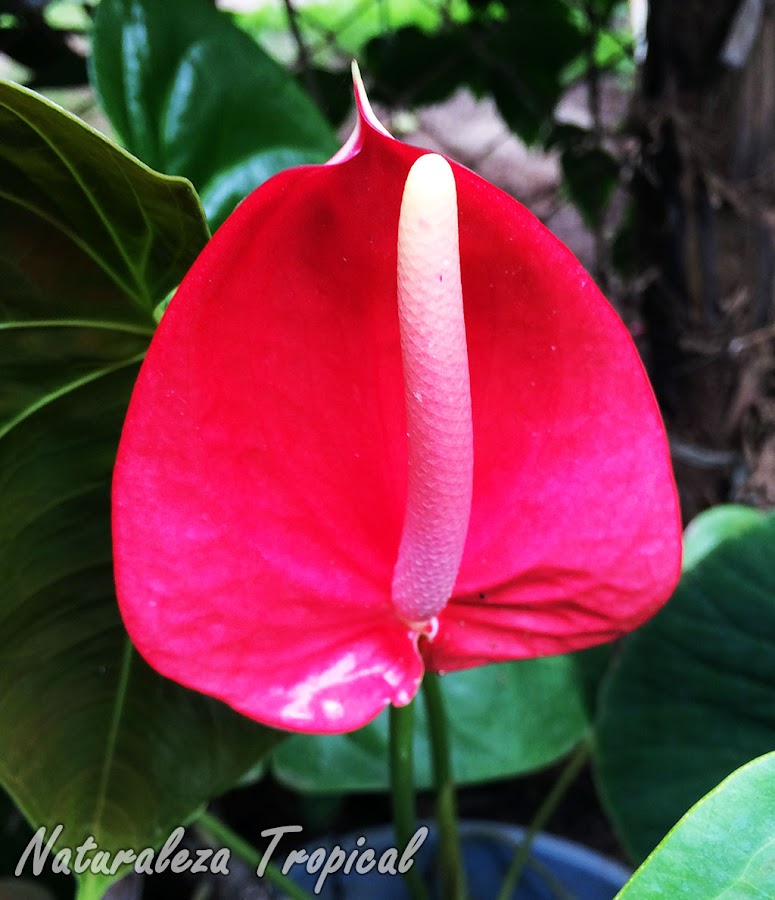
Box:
392 154 474 635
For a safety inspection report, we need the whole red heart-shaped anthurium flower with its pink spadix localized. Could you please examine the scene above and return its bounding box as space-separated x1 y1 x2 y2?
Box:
114 67 680 733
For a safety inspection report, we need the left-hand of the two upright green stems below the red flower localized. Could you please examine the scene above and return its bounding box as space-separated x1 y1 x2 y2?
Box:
390 701 428 900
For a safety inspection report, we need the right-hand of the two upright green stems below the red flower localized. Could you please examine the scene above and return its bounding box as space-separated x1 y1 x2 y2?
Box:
422 672 466 900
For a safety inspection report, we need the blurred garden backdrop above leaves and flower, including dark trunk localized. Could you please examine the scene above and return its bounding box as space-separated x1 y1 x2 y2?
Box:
6 0 775 521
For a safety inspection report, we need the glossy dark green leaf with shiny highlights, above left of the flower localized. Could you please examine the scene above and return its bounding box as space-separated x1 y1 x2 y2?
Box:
92 0 336 224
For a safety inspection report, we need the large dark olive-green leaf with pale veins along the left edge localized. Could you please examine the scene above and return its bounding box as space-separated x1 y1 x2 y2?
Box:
0 84 278 896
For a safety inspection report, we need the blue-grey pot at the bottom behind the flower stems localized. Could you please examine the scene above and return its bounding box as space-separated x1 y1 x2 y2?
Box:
290 821 631 900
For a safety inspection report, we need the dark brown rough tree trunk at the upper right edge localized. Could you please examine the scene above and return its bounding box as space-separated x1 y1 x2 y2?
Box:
634 0 775 520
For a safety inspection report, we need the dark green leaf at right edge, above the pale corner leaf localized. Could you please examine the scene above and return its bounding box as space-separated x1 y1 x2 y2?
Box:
596 510 775 859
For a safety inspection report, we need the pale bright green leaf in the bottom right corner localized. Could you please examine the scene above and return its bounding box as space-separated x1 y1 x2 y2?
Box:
617 753 775 900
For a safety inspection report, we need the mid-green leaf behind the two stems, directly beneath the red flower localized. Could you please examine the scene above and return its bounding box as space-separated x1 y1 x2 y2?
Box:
272 656 588 792
